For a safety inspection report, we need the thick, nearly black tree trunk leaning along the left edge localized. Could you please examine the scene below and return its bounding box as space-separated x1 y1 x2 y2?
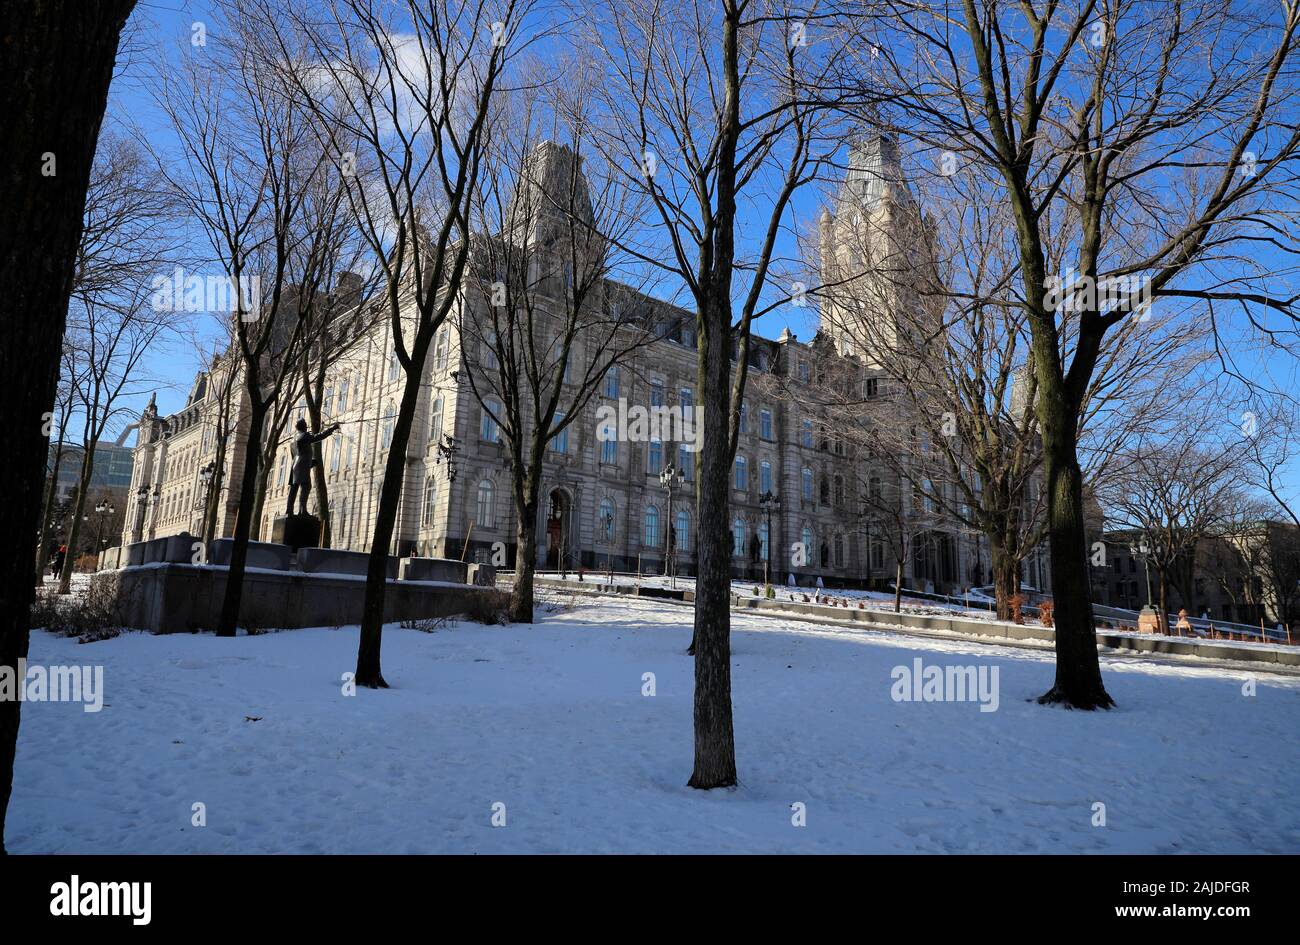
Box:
0 0 135 853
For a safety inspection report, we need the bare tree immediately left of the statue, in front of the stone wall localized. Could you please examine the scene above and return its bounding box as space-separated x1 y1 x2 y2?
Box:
156 22 353 636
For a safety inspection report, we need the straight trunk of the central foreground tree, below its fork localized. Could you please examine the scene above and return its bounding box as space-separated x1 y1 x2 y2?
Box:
688 305 736 789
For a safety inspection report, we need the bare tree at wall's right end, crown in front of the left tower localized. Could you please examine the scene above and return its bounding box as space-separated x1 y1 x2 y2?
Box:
456 70 655 623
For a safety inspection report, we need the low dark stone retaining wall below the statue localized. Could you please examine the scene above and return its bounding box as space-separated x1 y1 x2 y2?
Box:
91 563 508 633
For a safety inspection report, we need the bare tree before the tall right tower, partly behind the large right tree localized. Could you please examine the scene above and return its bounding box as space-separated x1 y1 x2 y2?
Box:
797 138 1210 620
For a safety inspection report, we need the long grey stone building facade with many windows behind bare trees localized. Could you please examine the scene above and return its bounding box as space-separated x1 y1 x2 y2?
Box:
124 138 1045 593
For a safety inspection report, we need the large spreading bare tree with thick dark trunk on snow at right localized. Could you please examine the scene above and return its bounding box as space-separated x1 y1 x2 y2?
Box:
852 0 1300 708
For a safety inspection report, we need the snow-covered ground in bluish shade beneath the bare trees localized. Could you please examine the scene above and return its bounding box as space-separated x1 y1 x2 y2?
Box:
8 595 1300 853
